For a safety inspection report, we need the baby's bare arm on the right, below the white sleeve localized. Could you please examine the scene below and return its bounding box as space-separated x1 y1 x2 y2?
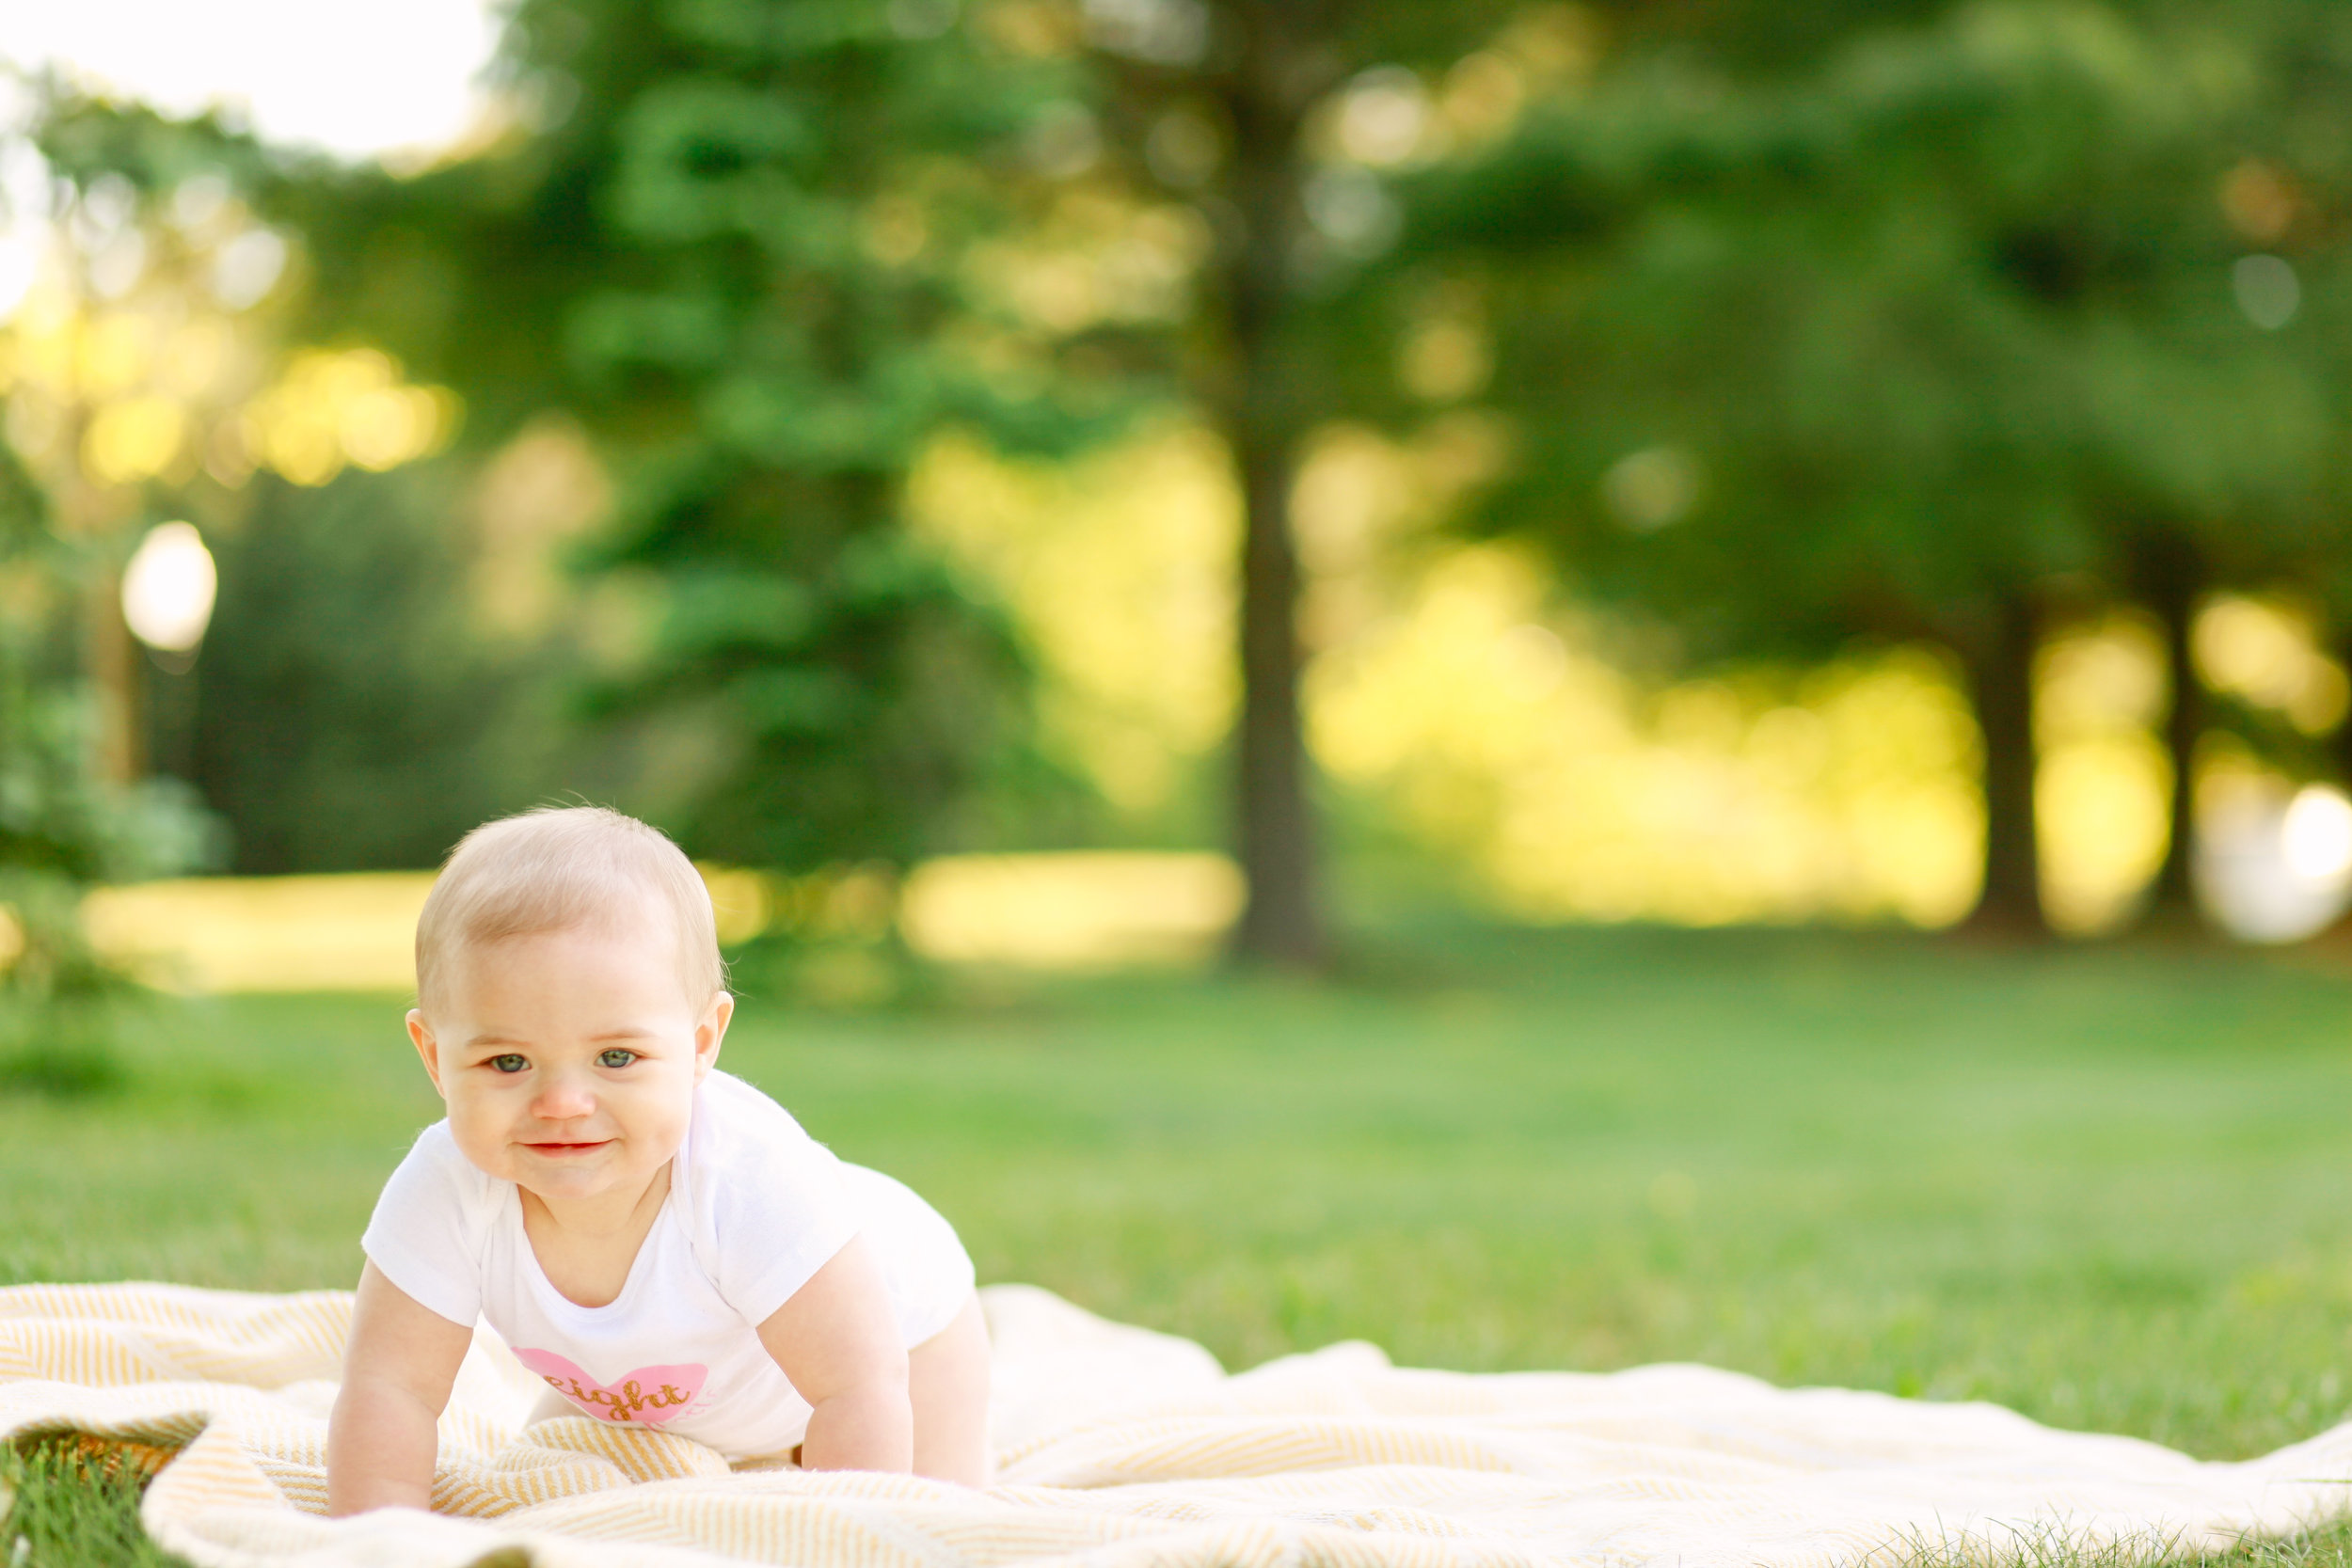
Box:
760 1242 915 1474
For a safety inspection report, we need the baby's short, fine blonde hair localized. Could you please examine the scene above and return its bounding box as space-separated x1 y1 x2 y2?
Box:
417 806 727 1013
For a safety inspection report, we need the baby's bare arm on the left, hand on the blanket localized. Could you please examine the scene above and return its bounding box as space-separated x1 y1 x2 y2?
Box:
327 1262 473 1514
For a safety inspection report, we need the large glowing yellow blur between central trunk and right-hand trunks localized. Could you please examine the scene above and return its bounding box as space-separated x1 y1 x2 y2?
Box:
1308 546 1983 927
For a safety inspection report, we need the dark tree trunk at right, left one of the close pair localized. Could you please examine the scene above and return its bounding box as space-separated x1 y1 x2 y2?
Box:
1969 590 2049 938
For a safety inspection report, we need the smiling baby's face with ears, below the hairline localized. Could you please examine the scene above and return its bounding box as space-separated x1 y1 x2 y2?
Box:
409 922 734 1204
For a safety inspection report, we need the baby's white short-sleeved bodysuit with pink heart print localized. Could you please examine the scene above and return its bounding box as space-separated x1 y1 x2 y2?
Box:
360 1072 972 1460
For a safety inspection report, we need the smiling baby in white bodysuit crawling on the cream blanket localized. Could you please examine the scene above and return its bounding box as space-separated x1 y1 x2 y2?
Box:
327 806 988 1514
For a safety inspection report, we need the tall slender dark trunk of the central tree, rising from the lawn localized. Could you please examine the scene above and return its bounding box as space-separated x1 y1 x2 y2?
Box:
1216 5 1329 969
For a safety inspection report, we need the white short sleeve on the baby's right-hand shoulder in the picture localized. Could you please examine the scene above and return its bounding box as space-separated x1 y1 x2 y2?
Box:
694 1072 859 1326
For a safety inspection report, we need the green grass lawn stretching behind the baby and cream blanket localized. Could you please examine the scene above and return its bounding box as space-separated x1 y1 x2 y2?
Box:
13 931 2352 1563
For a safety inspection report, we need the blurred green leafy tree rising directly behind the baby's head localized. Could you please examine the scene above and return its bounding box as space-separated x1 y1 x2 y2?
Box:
224 0 1075 867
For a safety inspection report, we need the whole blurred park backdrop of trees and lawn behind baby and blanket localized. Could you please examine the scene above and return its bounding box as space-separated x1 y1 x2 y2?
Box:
0 0 2352 1560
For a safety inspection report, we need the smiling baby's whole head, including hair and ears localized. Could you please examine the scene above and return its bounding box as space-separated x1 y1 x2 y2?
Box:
409 806 734 1201
